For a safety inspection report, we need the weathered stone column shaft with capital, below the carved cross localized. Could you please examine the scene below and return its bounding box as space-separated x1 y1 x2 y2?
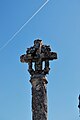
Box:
30 75 47 120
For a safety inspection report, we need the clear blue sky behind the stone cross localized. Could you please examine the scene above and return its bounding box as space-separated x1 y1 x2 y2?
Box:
0 0 80 120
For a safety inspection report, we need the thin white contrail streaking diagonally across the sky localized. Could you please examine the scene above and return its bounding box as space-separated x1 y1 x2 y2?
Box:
0 0 49 51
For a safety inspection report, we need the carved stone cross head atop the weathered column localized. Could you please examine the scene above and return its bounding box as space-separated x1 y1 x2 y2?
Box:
20 39 57 76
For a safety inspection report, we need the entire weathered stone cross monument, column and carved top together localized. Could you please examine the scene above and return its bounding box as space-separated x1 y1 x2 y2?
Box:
20 39 57 120
